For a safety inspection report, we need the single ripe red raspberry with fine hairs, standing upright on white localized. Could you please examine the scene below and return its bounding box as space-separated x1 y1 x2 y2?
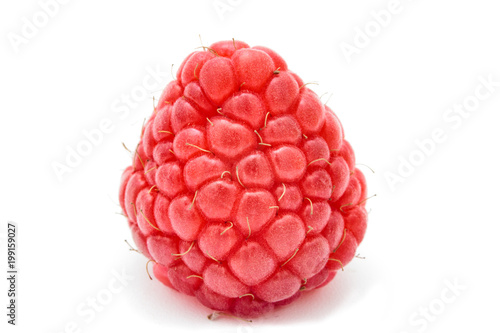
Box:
119 41 367 318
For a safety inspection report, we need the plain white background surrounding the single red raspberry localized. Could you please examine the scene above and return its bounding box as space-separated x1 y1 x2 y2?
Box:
0 0 500 333
